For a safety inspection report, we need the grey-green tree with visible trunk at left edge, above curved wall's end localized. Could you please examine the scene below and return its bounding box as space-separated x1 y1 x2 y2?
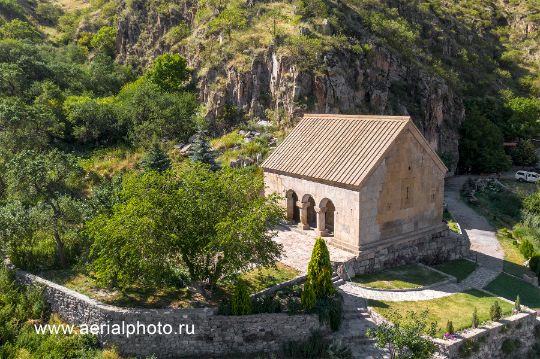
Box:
4 150 84 267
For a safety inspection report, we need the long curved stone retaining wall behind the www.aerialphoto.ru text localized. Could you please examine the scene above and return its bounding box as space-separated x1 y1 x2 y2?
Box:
16 271 329 358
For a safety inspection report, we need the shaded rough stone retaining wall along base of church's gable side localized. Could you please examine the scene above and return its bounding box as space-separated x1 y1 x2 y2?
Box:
337 227 470 280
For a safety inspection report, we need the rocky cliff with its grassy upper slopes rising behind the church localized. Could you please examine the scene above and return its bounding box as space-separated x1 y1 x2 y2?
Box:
107 0 532 169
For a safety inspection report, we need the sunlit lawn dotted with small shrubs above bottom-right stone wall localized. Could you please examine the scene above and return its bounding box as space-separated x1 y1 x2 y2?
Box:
368 289 513 337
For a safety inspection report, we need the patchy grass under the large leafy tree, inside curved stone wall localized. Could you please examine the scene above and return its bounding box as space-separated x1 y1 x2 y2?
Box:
39 263 299 308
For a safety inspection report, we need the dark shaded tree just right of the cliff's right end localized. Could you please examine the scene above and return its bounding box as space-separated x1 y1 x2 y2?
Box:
459 109 511 172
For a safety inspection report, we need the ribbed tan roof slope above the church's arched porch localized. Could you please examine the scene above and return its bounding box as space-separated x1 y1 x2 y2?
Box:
262 115 410 186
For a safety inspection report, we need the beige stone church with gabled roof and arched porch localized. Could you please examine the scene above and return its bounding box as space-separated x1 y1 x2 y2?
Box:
262 114 468 271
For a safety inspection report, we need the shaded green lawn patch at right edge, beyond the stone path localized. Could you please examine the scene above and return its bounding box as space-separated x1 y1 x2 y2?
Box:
485 273 540 310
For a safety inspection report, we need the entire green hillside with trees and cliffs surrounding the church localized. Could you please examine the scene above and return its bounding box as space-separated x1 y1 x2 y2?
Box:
0 0 540 286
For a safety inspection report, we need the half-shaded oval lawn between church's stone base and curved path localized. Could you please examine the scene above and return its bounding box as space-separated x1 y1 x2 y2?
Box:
353 264 447 289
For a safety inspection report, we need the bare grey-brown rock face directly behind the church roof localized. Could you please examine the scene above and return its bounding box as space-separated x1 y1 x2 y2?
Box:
198 48 464 172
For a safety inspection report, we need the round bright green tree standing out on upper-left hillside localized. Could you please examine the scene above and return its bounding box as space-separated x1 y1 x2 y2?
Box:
144 54 190 92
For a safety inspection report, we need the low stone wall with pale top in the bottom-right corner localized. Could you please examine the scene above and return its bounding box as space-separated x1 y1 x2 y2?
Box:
435 312 540 359
